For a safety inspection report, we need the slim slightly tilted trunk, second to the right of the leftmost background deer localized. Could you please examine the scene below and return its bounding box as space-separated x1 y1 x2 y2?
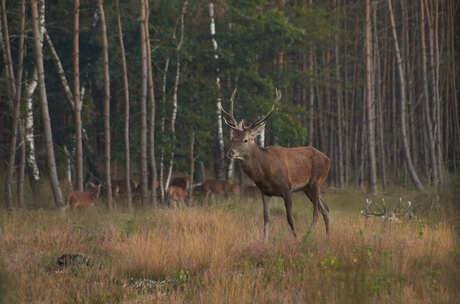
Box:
117 0 133 210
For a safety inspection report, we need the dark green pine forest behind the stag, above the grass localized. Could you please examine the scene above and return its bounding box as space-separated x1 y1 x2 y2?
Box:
0 0 460 206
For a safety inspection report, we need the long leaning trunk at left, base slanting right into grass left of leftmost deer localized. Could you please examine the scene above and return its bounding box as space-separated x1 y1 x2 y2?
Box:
30 0 65 210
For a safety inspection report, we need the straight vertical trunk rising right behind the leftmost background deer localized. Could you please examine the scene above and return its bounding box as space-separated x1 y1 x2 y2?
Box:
73 0 83 191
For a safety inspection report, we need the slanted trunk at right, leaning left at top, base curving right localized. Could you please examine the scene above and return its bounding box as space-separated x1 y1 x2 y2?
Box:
388 0 425 191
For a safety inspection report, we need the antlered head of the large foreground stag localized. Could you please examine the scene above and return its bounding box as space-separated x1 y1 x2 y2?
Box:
220 89 281 160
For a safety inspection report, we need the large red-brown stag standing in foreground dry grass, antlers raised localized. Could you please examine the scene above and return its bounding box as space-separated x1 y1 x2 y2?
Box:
221 89 330 241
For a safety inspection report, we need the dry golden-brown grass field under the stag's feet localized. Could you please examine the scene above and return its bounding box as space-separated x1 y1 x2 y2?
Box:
0 190 460 303
